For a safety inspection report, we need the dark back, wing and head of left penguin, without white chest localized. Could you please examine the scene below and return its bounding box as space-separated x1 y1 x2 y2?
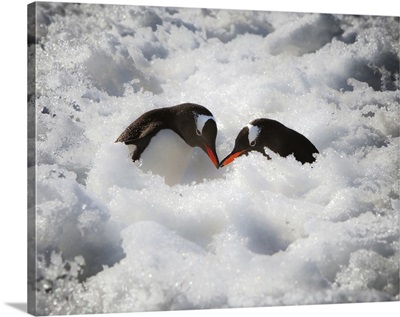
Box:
115 103 219 168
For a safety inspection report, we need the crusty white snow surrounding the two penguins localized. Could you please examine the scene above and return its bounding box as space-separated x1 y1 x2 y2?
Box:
28 3 400 315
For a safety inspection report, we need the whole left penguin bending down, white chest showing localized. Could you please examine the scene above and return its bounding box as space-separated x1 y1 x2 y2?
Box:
115 103 219 184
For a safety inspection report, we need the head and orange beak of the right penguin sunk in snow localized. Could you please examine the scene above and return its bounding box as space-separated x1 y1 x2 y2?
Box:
219 120 265 167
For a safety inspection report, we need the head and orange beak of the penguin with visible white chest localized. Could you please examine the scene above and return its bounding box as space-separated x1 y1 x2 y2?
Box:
177 105 219 168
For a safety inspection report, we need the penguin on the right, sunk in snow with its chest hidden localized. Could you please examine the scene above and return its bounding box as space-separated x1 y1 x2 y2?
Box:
220 118 319 167
